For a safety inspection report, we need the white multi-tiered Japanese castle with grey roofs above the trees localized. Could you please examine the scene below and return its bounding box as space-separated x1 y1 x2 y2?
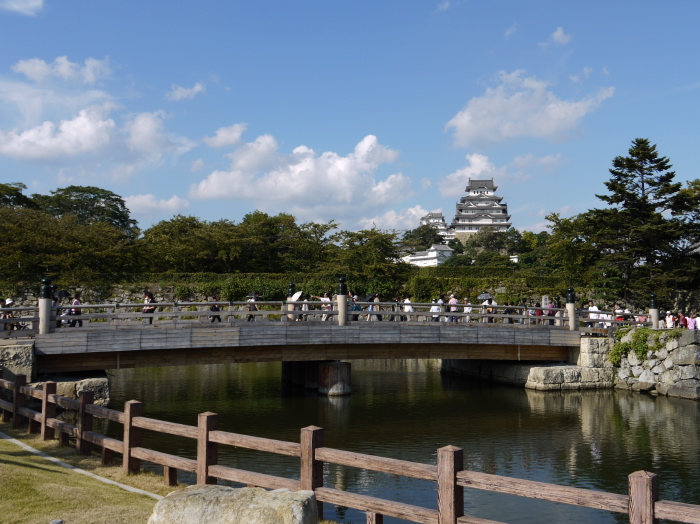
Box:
420 178 512 241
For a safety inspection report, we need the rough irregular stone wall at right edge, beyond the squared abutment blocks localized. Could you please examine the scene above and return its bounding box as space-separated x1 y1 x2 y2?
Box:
615 330 700 399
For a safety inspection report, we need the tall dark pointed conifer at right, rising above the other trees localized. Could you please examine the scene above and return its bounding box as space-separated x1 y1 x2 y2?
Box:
550 138 700 303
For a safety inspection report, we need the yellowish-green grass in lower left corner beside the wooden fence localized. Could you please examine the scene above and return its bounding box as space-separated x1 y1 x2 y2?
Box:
0 423 344 524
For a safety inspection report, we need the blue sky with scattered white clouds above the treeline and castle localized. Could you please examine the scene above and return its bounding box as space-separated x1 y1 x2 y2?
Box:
0 0 700 231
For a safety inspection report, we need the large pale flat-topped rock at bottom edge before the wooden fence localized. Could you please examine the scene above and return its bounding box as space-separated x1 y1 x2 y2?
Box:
148 485 318 524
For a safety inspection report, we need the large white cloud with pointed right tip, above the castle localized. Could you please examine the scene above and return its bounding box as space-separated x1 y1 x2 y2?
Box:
446 70 615 146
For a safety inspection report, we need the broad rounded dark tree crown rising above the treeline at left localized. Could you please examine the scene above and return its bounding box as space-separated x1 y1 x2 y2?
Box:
32 186 139 238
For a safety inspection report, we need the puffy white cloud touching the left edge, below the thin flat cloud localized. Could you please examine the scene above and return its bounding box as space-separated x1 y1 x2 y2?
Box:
0 106 116 160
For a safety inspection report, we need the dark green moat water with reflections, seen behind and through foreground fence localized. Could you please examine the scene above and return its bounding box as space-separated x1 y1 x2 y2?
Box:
109 361 700 523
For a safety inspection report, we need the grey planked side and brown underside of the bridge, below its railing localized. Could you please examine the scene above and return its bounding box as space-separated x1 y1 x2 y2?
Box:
35 322 580 373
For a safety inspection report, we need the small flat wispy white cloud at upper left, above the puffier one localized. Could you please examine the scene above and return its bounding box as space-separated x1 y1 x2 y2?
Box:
12 56 112 85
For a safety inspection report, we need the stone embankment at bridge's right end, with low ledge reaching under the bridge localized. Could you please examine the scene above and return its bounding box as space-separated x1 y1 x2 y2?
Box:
442 331 700 400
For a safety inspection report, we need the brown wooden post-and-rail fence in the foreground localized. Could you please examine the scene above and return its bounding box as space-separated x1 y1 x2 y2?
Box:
0 375 700 524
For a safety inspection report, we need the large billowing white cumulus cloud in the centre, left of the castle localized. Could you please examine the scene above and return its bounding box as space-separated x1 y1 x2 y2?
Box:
190 135 411 220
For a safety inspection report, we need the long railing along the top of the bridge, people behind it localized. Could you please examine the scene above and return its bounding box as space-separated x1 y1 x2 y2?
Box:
0 301 652 338
